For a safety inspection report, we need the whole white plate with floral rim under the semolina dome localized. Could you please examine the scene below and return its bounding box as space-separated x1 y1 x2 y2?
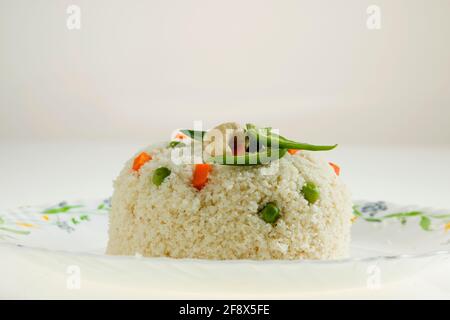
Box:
0 200 450 294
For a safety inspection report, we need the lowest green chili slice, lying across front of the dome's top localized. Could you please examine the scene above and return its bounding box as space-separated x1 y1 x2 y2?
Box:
206 149 287 166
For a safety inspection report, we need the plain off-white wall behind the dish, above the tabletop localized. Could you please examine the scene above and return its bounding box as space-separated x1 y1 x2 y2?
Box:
0 0 450 144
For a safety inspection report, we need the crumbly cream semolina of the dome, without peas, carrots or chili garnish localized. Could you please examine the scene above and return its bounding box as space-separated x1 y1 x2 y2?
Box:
107 147 352 260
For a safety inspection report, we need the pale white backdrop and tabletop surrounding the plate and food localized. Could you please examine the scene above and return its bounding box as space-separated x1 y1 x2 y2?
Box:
0 0 450 298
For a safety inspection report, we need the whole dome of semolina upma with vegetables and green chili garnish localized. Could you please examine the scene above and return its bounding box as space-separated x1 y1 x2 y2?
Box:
107 123 352 260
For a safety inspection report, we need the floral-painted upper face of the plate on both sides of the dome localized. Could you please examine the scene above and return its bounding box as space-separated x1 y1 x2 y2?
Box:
0 199 450 259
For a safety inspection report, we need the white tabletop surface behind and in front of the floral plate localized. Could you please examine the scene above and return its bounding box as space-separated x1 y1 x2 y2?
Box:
0 141 450 299
